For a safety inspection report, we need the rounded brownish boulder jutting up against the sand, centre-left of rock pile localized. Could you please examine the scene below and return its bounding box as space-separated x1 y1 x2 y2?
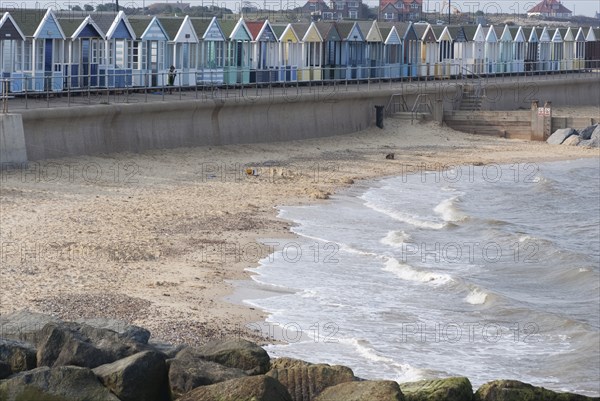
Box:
197 340 270 375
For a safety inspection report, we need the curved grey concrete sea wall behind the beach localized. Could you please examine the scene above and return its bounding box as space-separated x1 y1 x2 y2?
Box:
2 75 600 161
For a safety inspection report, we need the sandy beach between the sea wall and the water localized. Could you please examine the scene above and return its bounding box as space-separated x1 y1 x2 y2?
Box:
0 107 600 344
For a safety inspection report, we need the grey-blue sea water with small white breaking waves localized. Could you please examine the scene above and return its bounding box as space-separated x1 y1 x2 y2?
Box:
246 159 600 396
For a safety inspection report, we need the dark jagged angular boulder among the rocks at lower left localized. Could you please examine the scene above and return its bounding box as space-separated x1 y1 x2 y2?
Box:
37 323 149 368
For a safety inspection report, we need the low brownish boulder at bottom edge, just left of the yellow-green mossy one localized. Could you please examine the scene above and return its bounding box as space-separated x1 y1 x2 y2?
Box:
314 380 404 401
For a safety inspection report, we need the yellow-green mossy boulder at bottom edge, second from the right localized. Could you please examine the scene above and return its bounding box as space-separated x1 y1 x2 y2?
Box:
400 377 473 401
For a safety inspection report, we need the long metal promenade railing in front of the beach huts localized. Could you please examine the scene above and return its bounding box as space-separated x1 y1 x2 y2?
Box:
2 60 600 113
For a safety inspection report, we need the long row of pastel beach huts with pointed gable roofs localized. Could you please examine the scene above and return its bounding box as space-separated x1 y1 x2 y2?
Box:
0 9 600 93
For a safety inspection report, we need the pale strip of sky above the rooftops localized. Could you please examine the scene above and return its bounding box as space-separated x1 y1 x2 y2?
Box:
0 0 600 17
